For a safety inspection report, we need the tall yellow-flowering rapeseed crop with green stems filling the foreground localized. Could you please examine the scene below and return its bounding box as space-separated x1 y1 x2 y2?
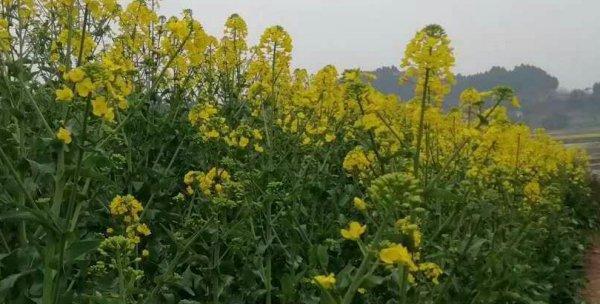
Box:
0 0 597 304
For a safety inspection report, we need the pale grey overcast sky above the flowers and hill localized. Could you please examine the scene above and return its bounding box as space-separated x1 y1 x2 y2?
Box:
161 0 600 89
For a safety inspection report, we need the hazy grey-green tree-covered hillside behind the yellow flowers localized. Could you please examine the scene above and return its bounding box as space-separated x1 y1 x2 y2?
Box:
372 64 600 130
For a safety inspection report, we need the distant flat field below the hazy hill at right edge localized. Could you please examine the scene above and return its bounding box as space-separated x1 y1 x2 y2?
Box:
550 129 600 175
